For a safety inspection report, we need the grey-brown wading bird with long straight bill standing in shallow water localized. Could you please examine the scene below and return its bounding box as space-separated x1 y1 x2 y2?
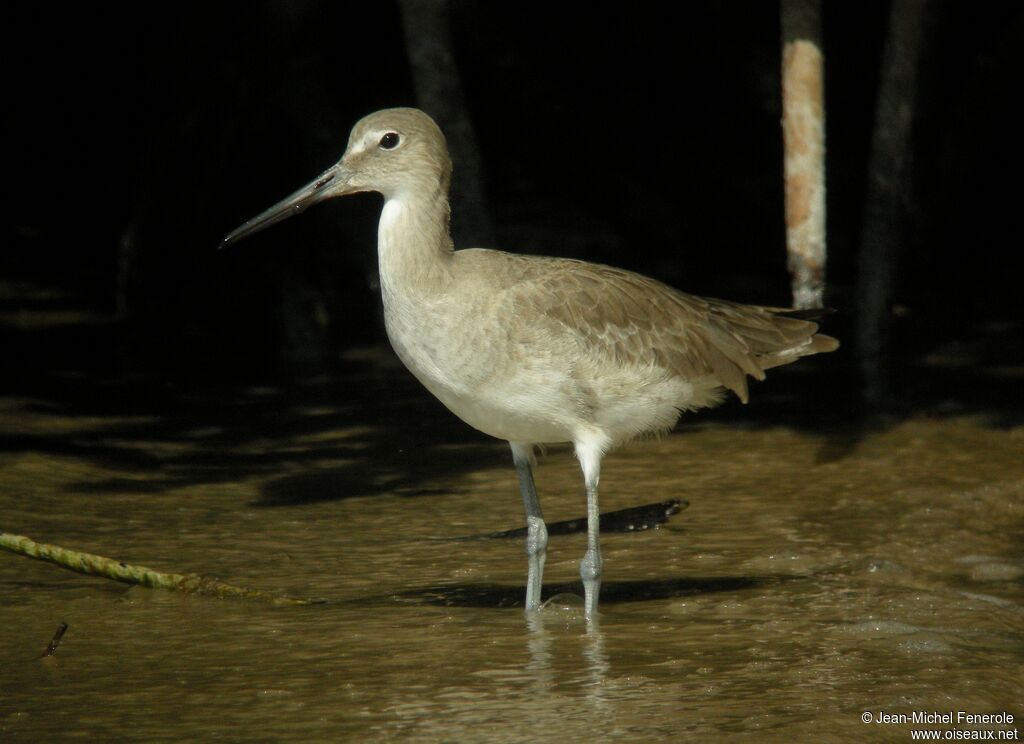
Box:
222 108 839 620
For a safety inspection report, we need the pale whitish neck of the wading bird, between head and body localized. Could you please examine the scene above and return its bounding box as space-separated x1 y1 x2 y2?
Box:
377 187 454 303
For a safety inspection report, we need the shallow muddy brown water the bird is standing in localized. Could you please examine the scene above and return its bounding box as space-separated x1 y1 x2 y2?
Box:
0 370 1024 742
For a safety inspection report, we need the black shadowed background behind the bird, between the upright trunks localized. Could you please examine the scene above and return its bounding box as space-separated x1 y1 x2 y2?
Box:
8 0 1024 425
